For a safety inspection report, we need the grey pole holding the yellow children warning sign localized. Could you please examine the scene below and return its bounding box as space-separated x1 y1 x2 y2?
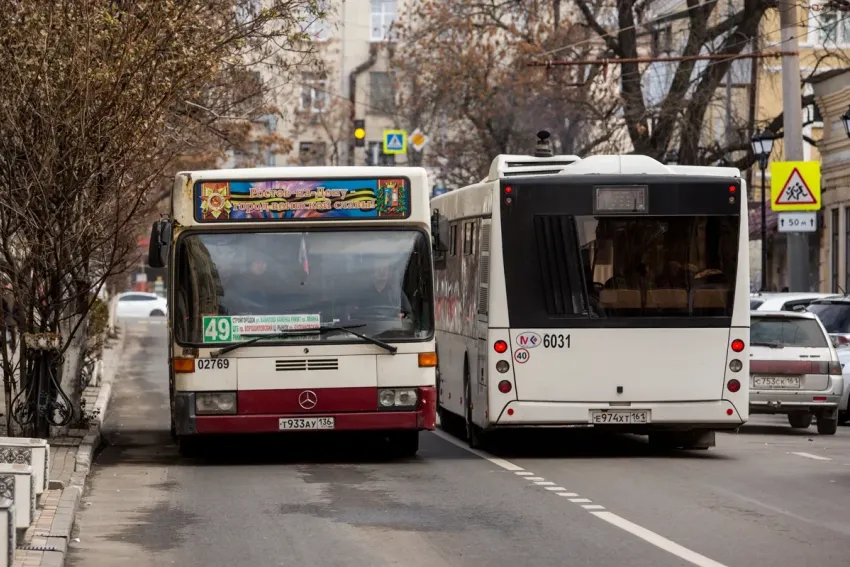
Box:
778 0 809 292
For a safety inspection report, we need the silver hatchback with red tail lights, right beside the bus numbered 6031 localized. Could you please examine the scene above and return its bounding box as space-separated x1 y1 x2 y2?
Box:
750 311 844 435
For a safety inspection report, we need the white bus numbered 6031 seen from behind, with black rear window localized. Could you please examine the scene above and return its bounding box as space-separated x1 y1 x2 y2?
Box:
431 155 750 448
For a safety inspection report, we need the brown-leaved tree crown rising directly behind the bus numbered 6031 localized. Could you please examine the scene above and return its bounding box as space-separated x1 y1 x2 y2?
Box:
393 0 617 184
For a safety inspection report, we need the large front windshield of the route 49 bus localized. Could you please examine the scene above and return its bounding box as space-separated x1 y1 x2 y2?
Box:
173 230 434 345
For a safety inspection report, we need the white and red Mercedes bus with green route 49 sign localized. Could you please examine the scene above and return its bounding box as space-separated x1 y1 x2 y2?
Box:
149 167 436 455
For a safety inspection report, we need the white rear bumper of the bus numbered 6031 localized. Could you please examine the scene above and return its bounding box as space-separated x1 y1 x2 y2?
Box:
491 400 748 429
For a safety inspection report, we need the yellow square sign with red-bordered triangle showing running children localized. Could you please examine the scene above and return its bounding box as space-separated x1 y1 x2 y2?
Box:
770 161 821 212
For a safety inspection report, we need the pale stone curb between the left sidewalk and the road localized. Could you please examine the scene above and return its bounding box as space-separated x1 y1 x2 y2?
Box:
15 327 126 567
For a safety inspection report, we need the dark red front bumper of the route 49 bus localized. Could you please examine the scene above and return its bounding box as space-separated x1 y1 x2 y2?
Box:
174 388 437 436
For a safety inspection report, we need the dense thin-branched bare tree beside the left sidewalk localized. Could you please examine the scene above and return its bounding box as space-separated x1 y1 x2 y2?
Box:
0 0 317 438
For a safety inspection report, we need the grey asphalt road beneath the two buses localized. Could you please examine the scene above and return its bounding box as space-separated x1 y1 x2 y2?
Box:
69 322 850 567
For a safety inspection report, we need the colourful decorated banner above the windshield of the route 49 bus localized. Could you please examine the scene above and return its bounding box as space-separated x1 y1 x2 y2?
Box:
195 178 410 222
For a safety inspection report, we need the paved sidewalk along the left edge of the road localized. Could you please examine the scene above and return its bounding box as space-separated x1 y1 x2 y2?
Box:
14 328 126 567
